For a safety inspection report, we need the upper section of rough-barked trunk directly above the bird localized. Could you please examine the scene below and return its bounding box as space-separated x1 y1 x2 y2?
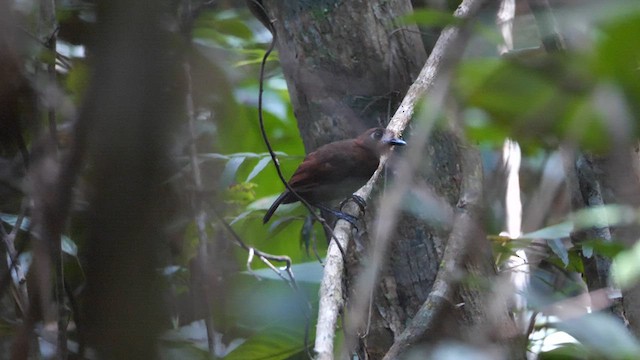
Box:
265 0 426 152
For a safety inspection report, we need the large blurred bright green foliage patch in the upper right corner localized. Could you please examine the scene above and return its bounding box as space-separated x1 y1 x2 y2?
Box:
455 2 640 154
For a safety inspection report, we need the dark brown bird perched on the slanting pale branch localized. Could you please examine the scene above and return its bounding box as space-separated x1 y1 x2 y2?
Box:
263 128 407 223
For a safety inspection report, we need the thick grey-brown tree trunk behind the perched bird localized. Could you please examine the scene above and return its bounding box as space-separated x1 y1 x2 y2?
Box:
265 0 524 359
